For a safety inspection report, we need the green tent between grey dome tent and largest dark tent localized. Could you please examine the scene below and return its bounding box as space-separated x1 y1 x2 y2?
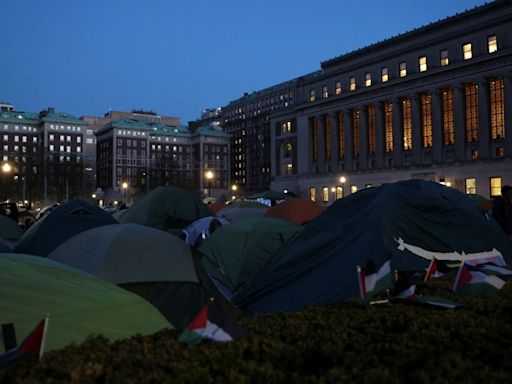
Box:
199 217 301 292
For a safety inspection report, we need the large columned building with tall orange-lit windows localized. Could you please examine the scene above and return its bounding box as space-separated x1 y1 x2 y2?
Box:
268 1 512 204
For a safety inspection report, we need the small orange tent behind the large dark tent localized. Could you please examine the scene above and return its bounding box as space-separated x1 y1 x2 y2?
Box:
265 199 324 225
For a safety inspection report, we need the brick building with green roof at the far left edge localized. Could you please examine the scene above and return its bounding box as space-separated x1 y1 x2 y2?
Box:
0 108 85 201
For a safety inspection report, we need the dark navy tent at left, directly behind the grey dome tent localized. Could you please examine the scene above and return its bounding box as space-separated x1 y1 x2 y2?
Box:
14 199 117 257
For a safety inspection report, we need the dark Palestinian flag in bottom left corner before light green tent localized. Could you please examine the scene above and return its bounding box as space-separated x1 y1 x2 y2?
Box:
0 317 48 370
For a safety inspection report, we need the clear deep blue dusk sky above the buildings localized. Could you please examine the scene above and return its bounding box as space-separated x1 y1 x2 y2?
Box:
0 0 486 123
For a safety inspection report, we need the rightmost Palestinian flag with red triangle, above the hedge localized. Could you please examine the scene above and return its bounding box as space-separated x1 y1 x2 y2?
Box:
453 263 505 296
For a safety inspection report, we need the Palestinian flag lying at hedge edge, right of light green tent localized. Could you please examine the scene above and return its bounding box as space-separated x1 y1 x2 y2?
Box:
178 301 247 345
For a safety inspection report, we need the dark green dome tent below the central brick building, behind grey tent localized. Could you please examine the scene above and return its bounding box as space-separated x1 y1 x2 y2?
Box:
119 187 215 233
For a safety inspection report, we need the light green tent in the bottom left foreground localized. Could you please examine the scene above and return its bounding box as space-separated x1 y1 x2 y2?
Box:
0 253 172 353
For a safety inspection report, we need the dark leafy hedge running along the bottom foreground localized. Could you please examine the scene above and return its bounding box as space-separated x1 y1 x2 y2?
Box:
0 280 512 384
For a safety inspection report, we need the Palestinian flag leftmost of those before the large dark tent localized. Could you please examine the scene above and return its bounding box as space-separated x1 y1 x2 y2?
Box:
357 260 393 300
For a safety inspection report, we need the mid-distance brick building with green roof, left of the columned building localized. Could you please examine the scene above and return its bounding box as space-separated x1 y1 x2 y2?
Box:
96 119 229 202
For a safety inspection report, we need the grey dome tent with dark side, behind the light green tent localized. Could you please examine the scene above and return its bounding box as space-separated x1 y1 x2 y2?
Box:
48 224 235 328
